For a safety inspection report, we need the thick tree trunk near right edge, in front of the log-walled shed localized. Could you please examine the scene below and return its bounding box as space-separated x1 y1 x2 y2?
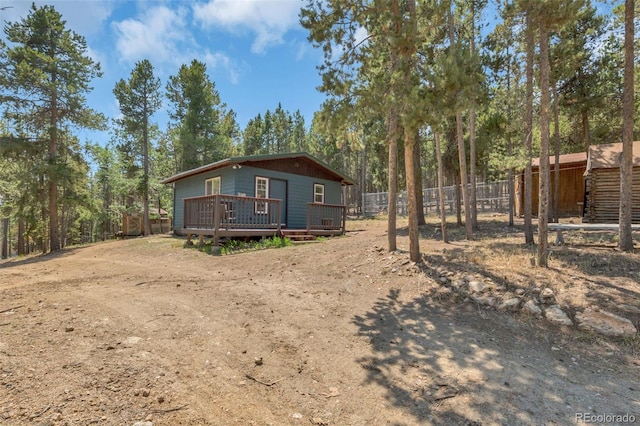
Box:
618 0 635 251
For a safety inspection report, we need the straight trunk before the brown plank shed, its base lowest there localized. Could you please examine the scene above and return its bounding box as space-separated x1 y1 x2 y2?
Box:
536 19 550 268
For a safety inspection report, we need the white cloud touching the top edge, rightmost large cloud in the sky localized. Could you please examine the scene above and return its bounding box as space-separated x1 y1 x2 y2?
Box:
193 0 303 53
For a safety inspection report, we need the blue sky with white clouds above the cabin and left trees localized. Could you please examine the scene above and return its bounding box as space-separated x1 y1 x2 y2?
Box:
0 0 324 143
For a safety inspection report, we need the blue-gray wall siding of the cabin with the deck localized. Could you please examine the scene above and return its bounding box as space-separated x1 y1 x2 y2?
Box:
173 166 342 230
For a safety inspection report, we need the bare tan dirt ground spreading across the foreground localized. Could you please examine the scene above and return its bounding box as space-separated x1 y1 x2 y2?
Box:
0 216 640 425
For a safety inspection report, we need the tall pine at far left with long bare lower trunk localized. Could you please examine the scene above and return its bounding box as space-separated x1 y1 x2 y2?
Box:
0 4 104 251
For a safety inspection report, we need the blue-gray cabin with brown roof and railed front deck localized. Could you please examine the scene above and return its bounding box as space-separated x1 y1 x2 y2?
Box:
162 153 355 240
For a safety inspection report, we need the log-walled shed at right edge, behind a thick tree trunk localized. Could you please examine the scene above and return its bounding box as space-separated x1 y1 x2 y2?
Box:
583 141 640 223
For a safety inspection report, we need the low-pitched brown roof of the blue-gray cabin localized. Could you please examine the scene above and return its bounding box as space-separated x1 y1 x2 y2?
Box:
161 152 355 185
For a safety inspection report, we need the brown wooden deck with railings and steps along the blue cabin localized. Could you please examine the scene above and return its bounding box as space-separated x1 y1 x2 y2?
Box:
180 194 346 244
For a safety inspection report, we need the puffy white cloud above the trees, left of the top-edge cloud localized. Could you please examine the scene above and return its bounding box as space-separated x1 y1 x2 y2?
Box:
112 6 190 63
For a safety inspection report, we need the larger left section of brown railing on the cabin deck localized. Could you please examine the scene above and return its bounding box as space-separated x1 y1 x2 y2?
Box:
184 194 282 233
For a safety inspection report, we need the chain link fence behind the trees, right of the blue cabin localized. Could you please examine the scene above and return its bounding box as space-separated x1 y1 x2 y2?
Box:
362 180 509 216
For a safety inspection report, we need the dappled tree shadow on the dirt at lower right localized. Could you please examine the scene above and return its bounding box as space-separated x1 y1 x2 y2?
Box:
353 290 640 425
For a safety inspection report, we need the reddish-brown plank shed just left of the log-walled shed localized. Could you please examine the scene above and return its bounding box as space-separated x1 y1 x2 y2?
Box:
516 152 587 216
